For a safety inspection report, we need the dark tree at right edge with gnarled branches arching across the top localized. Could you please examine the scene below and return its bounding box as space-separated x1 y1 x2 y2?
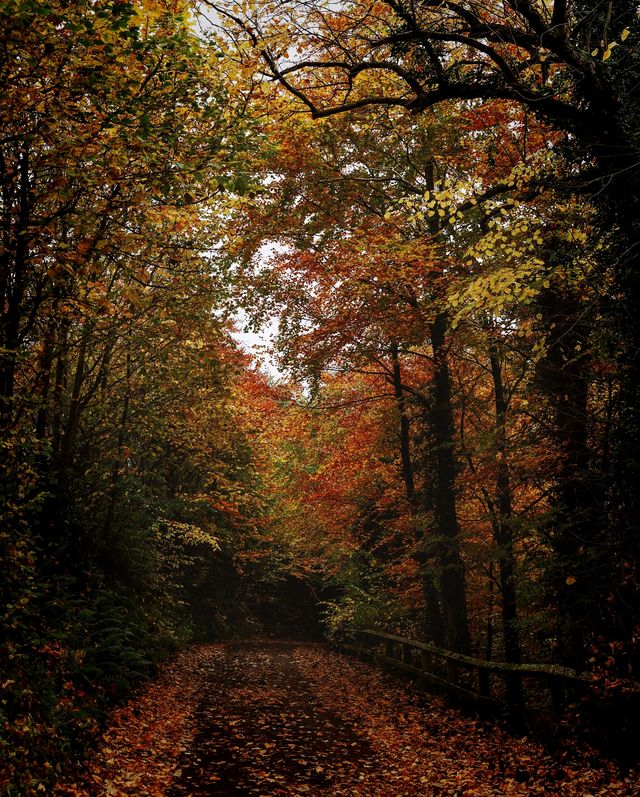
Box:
214 0 640 672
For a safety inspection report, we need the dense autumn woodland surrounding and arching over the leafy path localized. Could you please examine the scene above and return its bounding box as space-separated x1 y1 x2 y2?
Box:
0 0 640 795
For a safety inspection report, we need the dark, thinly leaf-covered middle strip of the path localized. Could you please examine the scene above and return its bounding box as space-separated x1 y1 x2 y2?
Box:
171 643 376 797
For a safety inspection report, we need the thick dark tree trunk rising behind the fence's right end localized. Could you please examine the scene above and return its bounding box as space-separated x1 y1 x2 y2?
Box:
538 286 596 668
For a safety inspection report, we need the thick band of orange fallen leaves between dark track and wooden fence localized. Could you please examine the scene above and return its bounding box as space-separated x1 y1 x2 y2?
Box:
297 651 640 797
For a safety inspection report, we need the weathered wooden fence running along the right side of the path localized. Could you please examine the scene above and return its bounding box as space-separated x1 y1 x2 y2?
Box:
338 629 591 716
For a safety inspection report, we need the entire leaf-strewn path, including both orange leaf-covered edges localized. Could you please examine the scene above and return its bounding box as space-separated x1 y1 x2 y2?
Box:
56 642 640 797
